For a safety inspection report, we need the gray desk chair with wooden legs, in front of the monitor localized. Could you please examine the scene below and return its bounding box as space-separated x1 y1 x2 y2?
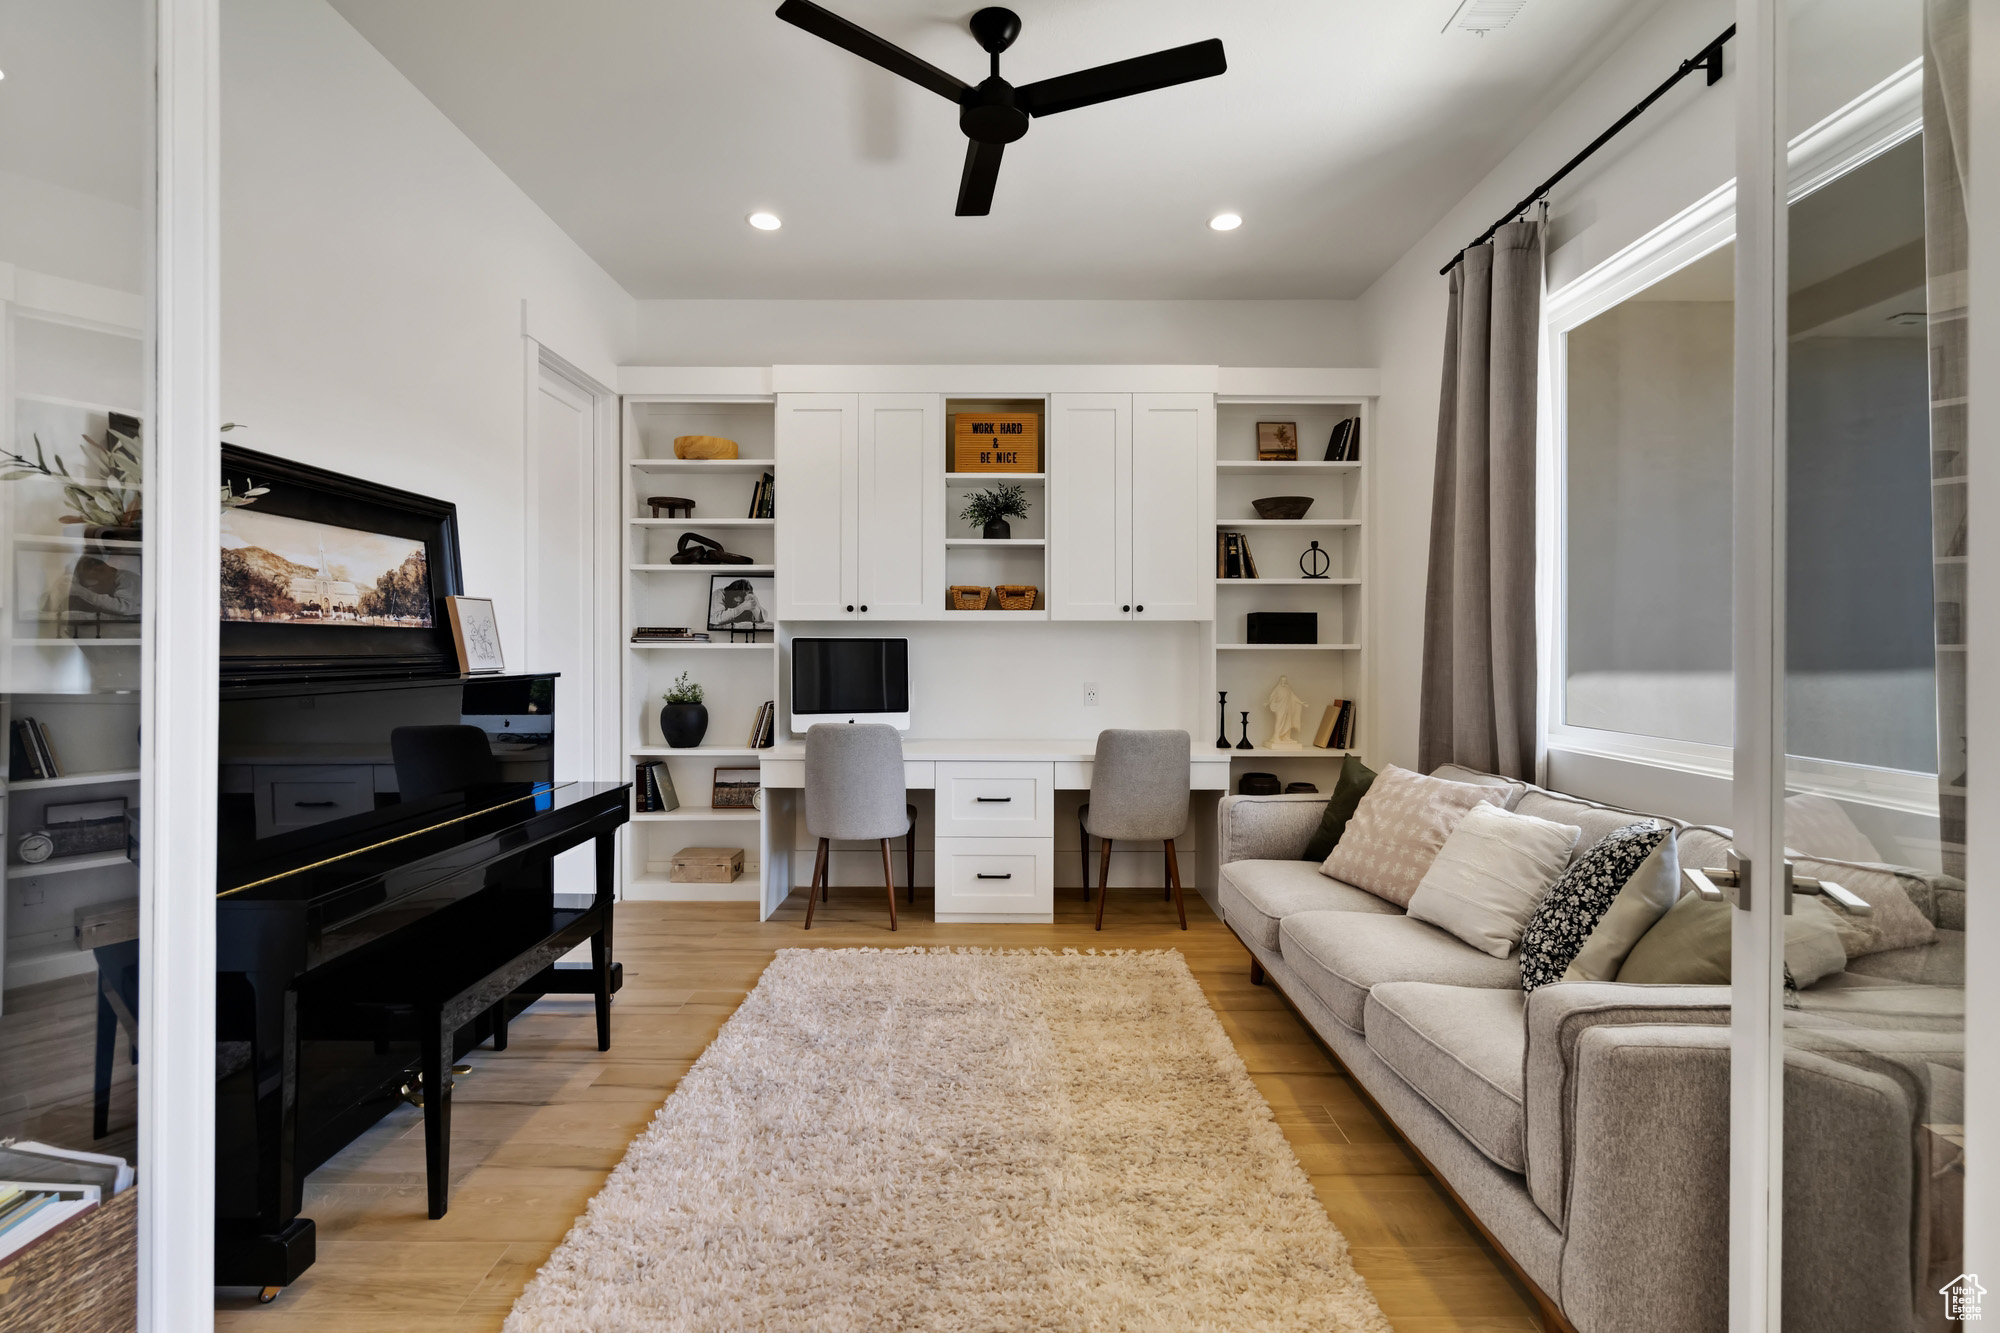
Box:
806 723 916 931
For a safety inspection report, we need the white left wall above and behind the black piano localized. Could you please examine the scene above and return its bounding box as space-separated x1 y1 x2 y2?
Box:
222 0 634 669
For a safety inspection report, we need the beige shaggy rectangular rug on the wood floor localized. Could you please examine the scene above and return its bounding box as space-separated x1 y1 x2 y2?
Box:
506 949 1388 1333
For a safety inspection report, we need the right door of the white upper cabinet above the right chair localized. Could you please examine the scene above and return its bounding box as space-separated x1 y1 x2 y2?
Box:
1132 394 1216 620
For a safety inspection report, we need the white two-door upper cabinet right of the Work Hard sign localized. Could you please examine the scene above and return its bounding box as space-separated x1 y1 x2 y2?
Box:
1048 394 1216 620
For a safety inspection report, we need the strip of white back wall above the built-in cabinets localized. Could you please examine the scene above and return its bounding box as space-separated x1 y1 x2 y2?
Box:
632 300 1368 366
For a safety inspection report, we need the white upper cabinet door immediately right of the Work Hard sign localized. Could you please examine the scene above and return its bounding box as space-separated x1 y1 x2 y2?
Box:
1046 394 1132 620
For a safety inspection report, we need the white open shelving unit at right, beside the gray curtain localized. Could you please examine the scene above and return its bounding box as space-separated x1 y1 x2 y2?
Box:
1206 396 1374 791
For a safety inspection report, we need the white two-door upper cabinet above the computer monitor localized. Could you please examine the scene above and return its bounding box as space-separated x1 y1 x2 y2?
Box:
774 394 944 620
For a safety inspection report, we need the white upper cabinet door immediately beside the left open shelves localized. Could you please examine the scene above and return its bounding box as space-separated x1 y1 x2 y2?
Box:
774 394 860 620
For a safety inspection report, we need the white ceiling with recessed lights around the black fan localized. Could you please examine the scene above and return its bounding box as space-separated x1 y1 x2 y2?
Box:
332 0 1656 298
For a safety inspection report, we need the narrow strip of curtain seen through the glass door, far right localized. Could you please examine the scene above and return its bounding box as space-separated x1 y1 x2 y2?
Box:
1924 0 1972 877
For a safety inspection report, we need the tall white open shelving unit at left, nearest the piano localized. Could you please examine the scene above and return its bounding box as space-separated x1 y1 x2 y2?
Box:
622 396 786 903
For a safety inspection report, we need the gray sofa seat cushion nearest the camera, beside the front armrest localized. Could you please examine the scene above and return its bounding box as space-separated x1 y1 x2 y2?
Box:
1368 981 1528 1173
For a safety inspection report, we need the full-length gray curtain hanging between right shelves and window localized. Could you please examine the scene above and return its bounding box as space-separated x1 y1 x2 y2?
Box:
1416 220 1544 781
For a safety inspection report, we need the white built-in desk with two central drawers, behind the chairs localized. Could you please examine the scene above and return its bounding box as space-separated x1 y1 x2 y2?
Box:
758 739 1230 923
